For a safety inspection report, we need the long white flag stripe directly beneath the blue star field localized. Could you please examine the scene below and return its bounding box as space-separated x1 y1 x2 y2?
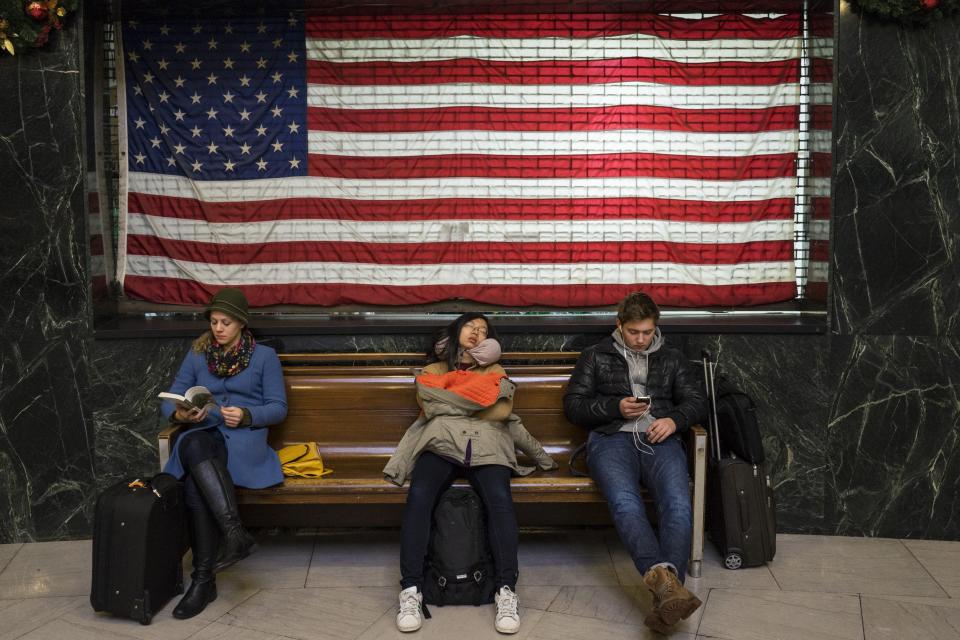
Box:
130 171 804 202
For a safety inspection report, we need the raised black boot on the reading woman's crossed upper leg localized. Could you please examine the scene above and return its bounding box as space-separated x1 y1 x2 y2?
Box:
190 458 256 573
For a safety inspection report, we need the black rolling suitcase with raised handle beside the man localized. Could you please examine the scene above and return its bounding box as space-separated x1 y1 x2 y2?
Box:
702 351 777 569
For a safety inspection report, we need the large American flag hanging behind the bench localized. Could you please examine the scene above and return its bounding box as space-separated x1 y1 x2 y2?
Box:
119 13 830 307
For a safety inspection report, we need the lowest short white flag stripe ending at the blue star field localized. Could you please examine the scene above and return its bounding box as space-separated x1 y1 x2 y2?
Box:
308 129 804 157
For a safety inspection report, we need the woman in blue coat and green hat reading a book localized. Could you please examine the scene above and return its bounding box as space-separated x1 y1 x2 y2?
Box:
163 288 287 618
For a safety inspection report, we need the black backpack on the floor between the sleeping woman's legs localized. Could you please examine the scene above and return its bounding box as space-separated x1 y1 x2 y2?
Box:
423 487 496 607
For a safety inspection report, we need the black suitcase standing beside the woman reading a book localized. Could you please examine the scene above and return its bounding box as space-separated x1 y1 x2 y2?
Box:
90 473 184 624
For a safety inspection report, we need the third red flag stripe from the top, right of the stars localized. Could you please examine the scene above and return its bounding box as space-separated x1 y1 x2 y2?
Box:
307 105 799 133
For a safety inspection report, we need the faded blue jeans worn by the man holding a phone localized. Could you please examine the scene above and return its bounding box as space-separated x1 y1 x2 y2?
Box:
587 431 693 582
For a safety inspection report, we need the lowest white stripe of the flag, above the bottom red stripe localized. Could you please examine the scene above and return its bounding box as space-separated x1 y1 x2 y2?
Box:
127 255 794 287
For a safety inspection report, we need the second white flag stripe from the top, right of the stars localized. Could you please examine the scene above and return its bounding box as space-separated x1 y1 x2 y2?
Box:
307 82 804 110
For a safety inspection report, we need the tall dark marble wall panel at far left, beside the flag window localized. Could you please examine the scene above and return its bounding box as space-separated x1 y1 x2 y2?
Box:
0 15 94 543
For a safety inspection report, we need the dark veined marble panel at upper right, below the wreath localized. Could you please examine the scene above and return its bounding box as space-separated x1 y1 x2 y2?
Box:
831 4 960 335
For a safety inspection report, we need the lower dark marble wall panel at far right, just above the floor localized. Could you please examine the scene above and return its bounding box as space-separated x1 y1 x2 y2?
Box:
825 335 960 539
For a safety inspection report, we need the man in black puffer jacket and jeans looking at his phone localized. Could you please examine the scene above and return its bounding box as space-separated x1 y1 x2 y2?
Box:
563 292 706 633
